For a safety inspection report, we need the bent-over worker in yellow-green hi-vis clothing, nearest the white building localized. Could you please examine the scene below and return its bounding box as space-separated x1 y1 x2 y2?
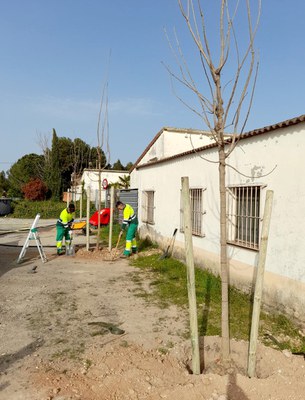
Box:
116 201 138 258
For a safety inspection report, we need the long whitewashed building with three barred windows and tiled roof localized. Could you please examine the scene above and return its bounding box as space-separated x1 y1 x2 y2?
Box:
131 115 305 322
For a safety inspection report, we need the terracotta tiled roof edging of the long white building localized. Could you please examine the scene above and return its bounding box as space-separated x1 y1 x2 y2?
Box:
129 114 305 172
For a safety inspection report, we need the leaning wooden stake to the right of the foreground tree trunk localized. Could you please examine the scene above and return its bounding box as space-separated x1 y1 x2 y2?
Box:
248 190 273 378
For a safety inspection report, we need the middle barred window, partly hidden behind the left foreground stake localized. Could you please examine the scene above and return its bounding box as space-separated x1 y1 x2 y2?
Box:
180 189 205 236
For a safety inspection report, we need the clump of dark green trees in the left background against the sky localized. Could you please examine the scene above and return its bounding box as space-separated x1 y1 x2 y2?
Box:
6 129 126 200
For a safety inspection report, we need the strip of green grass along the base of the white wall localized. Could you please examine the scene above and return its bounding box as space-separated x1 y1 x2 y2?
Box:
131 255 305 352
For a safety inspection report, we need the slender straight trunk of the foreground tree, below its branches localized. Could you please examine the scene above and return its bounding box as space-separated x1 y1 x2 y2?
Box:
218 145 230 361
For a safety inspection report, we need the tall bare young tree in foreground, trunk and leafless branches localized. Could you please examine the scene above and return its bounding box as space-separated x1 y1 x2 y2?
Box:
166 0 261 361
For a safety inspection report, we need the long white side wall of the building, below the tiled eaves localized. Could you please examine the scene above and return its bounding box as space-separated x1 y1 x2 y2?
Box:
131 123 305 321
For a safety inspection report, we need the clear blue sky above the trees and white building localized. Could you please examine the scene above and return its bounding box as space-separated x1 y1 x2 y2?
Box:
0 0 305 171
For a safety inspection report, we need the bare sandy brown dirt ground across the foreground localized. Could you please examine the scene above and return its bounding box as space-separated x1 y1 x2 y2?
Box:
0 225 305 400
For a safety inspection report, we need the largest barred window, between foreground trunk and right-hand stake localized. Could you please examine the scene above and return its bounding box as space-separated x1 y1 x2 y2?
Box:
227 186 261 250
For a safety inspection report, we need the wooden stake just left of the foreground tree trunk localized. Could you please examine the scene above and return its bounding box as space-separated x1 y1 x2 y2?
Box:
181 177 200 375
